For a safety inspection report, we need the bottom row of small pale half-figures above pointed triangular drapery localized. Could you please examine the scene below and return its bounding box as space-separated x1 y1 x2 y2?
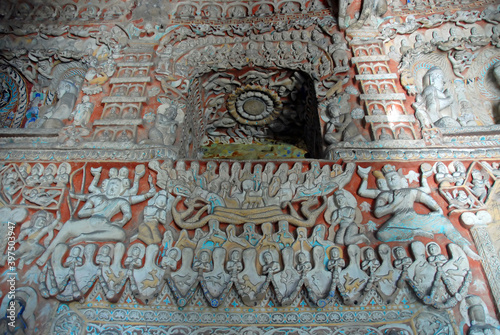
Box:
40 238 468 307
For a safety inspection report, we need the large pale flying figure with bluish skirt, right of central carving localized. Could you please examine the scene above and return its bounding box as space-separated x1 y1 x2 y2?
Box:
374 165 480 260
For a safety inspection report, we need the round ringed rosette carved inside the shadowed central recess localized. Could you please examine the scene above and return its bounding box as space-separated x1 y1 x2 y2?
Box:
227 85 283 126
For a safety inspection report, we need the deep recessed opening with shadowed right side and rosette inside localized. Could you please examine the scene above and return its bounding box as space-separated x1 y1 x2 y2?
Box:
198 67 321 160
